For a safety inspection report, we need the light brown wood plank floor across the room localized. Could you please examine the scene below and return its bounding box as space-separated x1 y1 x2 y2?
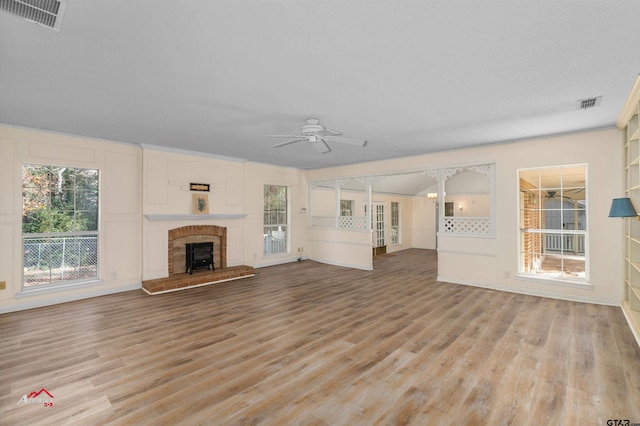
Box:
0 249 640 425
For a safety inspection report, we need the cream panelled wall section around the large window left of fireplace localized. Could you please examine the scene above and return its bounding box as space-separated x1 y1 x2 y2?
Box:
0 126 142 312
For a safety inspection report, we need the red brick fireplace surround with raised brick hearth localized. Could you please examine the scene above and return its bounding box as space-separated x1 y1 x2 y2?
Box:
142 225 254 294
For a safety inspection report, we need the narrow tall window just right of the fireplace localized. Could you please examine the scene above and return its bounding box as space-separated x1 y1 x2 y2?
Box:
263 185 288 254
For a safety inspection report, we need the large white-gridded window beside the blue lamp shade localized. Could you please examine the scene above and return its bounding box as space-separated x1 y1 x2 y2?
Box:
518 165 588 282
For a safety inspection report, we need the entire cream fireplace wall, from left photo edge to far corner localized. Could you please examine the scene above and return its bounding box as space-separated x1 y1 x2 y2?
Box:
0 126 308 313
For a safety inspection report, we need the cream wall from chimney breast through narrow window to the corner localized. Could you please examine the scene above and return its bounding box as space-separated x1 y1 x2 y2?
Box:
143 146 307 280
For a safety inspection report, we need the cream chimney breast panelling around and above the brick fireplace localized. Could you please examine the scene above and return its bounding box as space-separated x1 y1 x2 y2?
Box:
142 146 245 280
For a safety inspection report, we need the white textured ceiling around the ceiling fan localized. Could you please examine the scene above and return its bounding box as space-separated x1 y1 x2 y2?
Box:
0 0 640 169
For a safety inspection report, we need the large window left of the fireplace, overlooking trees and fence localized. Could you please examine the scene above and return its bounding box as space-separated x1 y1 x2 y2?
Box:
22 164 98 288
